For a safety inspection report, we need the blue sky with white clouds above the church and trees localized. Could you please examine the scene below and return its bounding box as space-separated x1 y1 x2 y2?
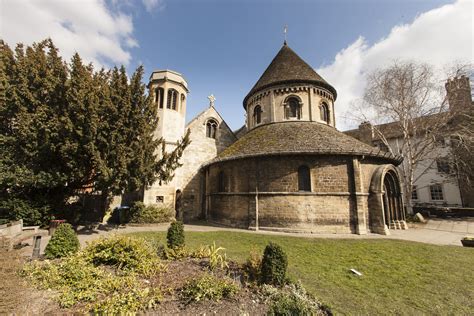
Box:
0 0 474 130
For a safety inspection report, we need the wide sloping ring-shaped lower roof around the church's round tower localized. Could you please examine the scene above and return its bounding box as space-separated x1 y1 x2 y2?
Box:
208 121 401 165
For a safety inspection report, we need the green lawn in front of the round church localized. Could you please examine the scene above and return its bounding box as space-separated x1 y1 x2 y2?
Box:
133 231 474 315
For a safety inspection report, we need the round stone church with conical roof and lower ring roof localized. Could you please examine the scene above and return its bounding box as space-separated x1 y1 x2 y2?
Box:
200 43 406 234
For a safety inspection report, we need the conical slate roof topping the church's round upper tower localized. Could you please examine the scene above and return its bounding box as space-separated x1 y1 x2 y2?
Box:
244 43 337 108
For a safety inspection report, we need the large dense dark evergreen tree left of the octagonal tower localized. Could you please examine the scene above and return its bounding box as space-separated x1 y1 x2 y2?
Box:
0 39 189 222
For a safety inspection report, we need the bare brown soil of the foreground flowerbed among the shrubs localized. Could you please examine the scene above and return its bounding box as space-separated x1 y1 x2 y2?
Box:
0 250 268 315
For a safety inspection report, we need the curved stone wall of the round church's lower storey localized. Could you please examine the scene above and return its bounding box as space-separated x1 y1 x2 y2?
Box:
206 155 396 234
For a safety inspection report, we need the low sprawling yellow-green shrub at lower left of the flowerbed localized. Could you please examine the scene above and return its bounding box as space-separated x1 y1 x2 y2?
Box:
21 253 161 315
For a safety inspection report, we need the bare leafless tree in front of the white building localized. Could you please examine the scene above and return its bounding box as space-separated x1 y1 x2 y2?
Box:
357 62 451 213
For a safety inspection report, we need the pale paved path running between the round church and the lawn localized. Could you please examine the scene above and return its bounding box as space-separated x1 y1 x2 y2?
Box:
25 218 474 254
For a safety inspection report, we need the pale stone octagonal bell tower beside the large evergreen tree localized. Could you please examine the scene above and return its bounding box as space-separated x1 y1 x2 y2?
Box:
143 70 189 207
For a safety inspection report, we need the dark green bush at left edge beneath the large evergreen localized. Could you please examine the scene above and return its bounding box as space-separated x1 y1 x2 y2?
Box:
0 198 52 226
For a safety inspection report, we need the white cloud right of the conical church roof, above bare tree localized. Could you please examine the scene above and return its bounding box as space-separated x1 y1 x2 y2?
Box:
318 0 474 130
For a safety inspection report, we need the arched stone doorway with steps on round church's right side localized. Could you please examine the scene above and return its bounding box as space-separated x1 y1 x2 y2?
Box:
369 165 407 235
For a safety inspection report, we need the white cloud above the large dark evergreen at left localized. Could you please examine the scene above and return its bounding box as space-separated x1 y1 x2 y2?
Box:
0 0 138 66
